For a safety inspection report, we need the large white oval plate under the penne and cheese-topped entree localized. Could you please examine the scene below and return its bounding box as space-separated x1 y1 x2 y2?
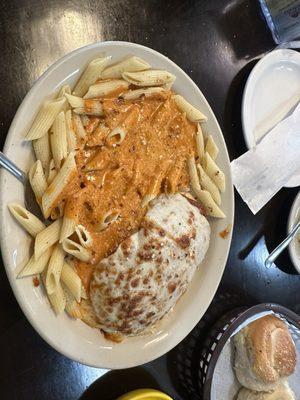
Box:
0 42 234 368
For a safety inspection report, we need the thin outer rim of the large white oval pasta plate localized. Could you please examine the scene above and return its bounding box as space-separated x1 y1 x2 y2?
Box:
0 41 235 369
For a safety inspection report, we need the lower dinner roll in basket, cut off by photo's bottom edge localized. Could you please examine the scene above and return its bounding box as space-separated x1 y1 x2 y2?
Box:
237 382 295 400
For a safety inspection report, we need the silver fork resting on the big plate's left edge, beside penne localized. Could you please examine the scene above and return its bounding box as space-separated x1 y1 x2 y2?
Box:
0 151 44 221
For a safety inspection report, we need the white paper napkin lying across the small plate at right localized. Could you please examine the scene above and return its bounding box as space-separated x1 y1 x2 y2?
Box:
231 103 300 214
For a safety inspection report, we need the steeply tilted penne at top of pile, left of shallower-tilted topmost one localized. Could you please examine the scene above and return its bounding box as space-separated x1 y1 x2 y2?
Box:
73 57 111 97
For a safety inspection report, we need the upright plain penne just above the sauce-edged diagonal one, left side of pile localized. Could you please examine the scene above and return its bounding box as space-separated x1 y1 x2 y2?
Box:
50 111 68 169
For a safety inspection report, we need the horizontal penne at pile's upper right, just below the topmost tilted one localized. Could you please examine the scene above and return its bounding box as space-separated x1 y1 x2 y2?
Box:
122 69 176 86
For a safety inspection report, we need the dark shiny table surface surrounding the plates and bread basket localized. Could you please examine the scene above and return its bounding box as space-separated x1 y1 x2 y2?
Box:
0 0 300 400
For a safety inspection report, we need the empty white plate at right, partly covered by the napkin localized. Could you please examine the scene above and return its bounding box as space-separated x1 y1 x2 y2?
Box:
242 49 300 187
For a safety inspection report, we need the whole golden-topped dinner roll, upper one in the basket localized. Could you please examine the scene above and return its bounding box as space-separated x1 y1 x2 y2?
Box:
234 315 296 392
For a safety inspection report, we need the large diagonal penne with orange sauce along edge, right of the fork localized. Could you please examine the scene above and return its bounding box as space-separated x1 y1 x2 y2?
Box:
42 153 77 218
